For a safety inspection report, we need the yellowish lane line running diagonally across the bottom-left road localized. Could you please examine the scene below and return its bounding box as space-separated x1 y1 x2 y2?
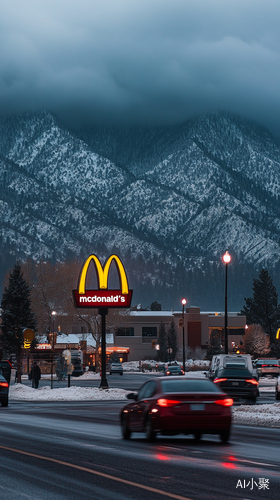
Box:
0 445 193 500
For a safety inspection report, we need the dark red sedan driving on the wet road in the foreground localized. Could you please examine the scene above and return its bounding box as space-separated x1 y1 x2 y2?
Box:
120 376 233 443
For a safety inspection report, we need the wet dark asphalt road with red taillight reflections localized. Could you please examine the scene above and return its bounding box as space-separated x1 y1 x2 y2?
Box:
0 401 280 500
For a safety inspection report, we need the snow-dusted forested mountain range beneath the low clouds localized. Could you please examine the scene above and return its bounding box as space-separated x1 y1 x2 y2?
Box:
0 112 280 307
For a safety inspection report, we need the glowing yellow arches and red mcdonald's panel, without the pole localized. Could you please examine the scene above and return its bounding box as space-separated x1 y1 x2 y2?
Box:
73 255 132 308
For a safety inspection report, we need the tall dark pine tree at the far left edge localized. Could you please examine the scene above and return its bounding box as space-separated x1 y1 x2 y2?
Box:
0 264 36 382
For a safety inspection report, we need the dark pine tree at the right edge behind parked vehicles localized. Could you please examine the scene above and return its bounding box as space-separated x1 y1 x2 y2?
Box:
241 269 278 343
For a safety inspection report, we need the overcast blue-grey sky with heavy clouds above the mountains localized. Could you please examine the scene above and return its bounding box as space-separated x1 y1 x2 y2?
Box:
0 0 280 136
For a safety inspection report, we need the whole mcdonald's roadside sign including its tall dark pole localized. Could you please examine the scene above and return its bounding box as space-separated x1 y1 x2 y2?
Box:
73 255 133 389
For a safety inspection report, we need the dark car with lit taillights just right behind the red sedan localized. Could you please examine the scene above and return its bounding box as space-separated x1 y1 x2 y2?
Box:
214 365 259 403
